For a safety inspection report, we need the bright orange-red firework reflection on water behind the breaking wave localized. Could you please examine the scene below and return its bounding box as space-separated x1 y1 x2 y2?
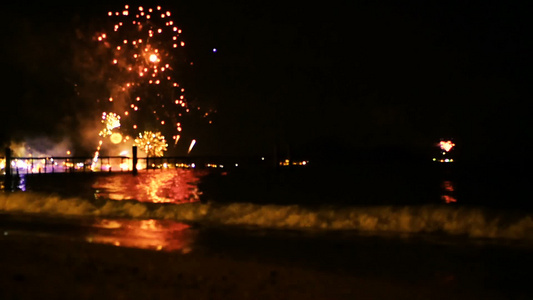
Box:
93 169 203 203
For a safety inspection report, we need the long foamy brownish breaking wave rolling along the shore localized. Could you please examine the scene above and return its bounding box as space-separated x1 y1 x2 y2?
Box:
0 192 533 240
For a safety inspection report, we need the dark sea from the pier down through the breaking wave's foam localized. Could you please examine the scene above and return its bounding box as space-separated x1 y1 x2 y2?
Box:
0 165 533 240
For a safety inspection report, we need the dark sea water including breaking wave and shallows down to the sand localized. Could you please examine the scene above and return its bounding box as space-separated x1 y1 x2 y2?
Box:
0 166 533 299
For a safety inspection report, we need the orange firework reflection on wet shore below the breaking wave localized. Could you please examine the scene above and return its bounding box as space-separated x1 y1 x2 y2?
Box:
86 219 196 253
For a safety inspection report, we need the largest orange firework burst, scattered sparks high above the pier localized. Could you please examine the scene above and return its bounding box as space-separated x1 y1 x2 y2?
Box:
89 5 209 160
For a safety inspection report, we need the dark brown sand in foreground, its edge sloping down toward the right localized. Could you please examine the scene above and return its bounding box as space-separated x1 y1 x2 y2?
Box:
0 233 531 300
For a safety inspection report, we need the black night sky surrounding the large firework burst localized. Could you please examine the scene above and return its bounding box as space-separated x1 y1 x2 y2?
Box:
0 1 533 163
